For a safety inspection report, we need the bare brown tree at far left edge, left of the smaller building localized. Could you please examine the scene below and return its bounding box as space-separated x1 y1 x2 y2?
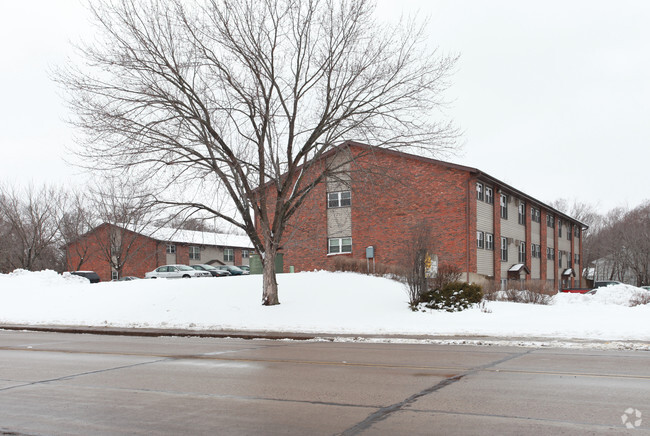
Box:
0 186 61 272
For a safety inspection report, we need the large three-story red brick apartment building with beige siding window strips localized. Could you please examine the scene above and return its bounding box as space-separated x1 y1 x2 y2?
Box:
270 142 586 289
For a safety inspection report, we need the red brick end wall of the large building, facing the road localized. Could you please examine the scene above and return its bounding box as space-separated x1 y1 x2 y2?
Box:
270 149 476 272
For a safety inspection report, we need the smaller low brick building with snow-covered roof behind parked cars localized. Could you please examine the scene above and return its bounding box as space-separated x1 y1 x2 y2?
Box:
65 223 253 281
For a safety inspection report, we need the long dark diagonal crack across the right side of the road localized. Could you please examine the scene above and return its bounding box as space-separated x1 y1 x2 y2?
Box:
339 349 535 436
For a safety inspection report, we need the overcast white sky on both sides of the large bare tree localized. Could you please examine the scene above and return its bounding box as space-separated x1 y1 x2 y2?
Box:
0 0 650 212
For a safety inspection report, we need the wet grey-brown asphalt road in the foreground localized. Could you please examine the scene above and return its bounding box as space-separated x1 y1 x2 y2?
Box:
0 331 650 435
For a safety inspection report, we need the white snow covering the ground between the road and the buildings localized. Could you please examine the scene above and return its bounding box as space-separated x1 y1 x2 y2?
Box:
0 270 650 348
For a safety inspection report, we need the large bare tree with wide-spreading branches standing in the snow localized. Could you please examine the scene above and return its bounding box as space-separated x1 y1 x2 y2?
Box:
57 0 458 305
